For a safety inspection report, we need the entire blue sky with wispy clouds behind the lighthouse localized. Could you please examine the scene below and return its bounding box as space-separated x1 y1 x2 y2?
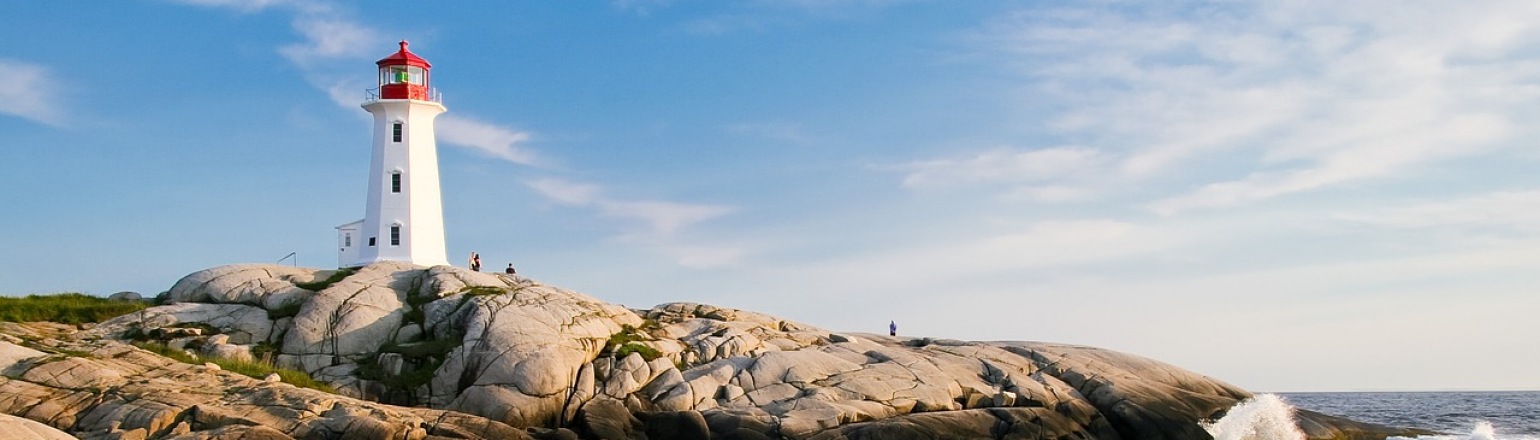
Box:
0 0 1540 391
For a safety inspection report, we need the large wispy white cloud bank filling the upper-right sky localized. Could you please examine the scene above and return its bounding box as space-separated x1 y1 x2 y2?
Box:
973 0 1540 214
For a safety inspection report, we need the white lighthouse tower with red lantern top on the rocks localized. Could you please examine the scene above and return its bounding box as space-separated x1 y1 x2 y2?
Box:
337 40 450 268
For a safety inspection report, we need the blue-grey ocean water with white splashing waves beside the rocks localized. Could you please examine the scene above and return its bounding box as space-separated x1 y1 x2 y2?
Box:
1203 391 1540 440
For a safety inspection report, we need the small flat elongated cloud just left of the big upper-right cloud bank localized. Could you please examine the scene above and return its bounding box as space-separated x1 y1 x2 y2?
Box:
901 146 1103 189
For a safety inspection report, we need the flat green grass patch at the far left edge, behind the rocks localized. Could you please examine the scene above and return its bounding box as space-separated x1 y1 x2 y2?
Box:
0 292 149 325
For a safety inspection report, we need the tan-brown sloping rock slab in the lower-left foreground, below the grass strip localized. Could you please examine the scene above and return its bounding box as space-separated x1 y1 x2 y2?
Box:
0 321 530 438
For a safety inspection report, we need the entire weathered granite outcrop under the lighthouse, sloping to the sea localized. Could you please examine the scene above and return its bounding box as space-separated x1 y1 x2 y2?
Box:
0 263 1411 438
